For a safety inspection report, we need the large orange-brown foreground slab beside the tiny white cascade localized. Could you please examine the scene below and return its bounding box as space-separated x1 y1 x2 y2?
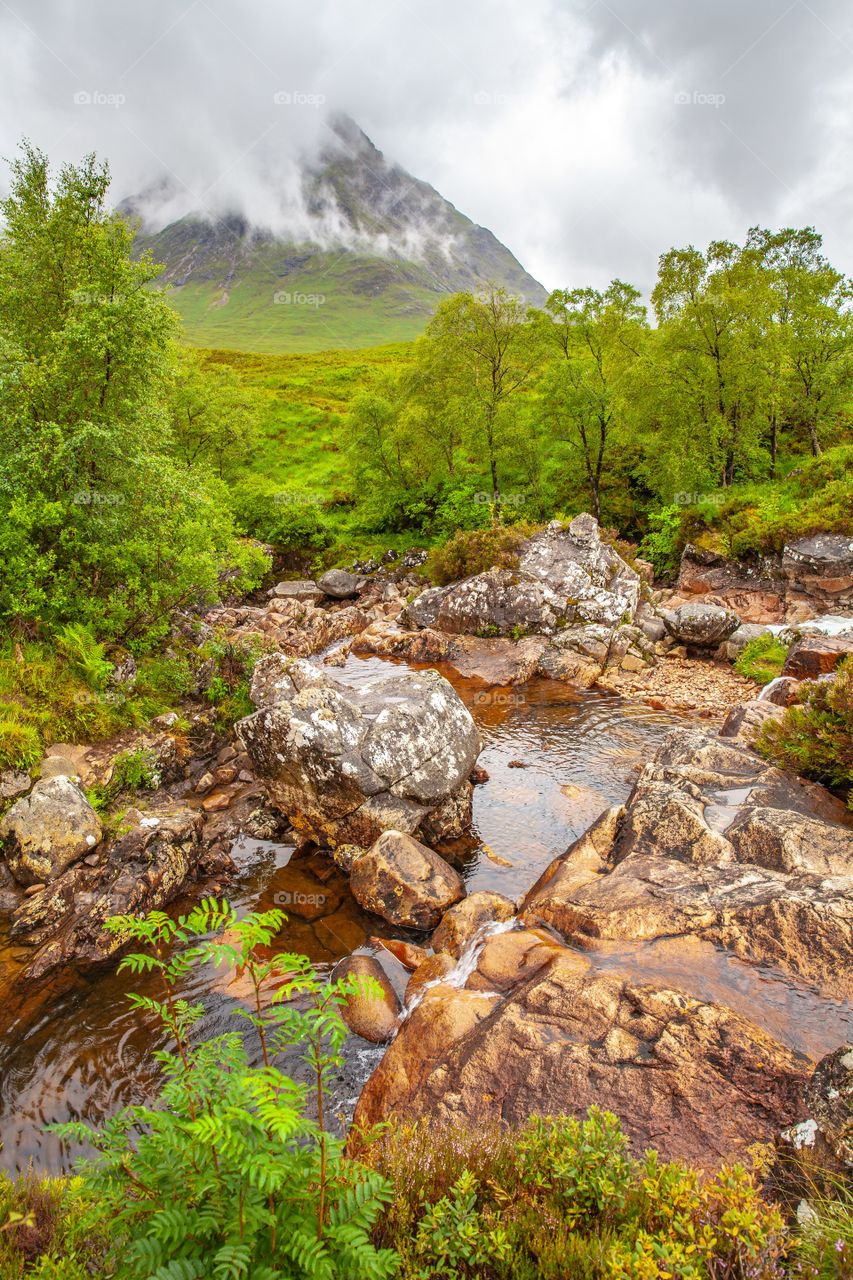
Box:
355 931 807 1169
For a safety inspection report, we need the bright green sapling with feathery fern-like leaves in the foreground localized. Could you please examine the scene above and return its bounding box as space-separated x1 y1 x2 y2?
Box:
54 900 396 1280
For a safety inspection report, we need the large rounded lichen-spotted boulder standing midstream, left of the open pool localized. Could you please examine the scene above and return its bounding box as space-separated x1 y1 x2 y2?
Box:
237 655 480 847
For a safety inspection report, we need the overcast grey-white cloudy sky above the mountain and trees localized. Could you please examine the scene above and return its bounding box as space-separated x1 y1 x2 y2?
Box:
0 0 853 289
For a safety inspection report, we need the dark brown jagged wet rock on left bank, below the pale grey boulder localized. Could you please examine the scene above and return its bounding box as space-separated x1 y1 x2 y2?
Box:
12 803 204 983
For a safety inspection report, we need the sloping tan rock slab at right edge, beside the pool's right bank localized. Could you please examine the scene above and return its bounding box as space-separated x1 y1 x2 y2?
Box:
520 728 853 996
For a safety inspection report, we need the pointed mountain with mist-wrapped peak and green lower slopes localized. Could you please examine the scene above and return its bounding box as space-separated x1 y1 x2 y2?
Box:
128 116 547 353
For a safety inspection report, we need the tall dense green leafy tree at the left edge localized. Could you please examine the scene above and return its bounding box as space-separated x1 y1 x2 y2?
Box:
0 146 265 643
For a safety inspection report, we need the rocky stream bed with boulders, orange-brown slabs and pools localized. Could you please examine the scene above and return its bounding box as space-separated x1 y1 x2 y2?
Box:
0 516 853 1167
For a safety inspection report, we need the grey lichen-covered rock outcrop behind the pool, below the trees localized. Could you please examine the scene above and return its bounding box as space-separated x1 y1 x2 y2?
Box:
406 515 640 635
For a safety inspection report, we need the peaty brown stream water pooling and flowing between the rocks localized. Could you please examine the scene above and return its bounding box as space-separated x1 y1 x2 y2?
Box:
0 657 853 1170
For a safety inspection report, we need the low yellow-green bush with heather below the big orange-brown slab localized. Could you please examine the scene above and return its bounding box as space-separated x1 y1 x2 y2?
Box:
366 1107 790 1280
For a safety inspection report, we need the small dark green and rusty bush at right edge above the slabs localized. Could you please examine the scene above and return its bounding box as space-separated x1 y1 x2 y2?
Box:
756 658 853 808
